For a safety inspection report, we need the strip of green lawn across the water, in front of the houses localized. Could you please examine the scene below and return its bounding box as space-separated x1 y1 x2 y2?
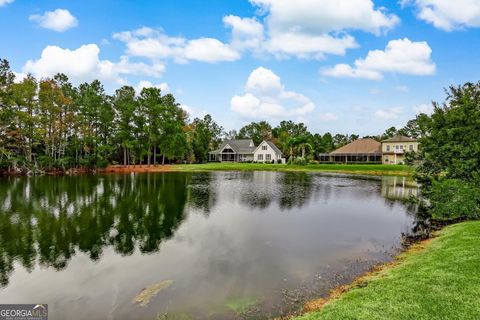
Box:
173 162 414 175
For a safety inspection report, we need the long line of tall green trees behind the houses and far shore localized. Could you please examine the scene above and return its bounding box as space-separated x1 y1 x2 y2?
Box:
0 59 422 173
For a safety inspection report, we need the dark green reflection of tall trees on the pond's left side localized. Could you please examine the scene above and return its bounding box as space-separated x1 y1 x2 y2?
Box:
0 174 189 285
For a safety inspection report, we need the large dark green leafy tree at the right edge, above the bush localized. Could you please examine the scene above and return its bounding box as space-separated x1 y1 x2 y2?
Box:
419 82 480 181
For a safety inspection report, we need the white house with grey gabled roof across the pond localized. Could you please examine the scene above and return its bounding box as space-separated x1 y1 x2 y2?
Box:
209 139 285 162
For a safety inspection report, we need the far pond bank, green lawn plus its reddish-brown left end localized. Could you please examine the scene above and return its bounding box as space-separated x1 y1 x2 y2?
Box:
101 163 414 176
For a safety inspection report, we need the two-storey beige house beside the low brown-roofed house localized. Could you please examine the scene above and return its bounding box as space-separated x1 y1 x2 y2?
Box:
382 135 418 164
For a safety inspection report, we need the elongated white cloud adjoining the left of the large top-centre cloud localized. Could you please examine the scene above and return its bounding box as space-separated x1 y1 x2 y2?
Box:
113 27 240 63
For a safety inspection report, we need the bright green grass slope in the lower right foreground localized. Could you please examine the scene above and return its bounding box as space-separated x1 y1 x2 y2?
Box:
297 221 480 320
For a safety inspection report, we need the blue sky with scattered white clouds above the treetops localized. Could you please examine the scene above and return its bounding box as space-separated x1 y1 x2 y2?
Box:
0 0 480 135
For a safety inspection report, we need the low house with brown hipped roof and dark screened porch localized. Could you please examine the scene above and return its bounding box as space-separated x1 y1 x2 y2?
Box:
320 138 382 163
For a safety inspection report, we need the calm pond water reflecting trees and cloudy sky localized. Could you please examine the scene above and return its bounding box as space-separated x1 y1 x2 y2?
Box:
0 172 417 319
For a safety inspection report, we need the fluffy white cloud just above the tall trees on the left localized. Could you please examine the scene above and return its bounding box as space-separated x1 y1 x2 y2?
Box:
22 44 165 84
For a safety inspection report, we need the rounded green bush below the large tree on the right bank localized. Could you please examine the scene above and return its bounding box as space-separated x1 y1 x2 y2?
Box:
427 179 480 220
